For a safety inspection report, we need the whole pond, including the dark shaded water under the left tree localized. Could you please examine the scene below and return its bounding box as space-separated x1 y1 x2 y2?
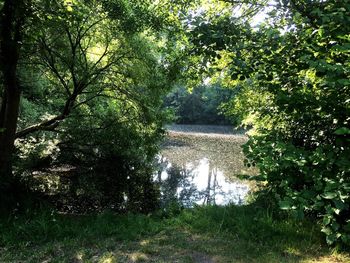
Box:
23 125 256 213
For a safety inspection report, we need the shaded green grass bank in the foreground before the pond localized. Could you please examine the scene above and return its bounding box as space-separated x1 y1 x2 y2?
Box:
0 204 350 263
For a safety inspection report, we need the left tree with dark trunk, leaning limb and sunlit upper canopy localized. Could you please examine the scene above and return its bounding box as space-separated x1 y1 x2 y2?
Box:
0 0 187 211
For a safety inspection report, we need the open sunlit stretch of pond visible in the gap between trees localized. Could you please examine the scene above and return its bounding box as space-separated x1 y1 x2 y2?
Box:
154 125 256 207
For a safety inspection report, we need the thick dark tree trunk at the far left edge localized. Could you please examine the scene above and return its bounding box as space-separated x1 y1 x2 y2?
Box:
0 0 24 209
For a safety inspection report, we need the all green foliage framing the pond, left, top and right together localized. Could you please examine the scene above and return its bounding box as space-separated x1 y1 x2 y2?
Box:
0 0 350 252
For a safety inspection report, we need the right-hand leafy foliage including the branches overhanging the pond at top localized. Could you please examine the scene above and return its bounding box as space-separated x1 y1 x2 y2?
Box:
190 1 350 248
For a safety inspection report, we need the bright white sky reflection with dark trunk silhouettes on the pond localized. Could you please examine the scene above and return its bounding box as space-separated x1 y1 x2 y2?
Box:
155 155 249 207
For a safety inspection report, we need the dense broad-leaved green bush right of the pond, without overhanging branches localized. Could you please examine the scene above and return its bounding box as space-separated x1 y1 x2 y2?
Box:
239 2 350 248
